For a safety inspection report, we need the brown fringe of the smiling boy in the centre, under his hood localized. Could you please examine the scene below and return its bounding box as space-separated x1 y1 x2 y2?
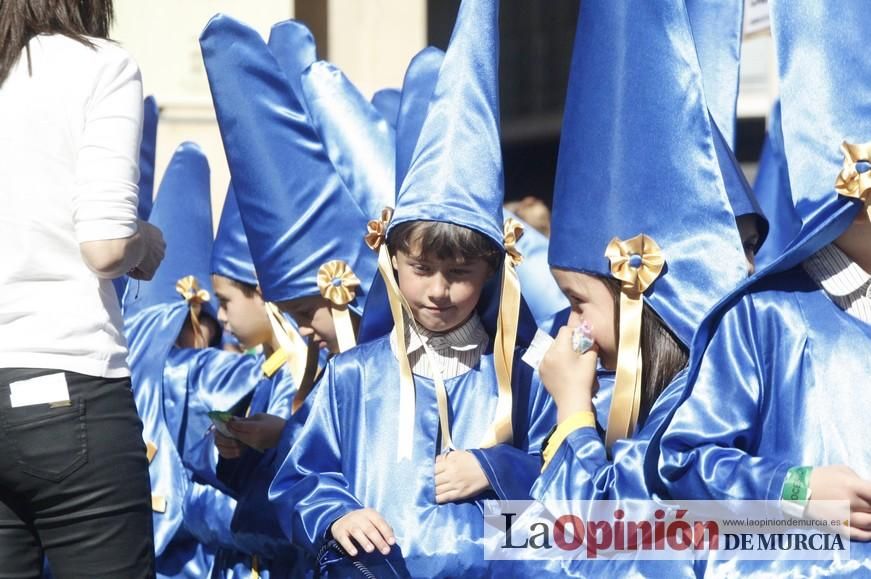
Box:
387 221 505 272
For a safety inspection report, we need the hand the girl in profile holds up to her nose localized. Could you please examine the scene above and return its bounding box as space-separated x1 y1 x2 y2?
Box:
538 326 599 422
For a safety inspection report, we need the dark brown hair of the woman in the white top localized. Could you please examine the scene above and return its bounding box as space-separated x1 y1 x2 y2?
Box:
0 0 114 86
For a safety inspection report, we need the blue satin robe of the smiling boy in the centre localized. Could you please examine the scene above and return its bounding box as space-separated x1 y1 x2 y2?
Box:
270 336 555 577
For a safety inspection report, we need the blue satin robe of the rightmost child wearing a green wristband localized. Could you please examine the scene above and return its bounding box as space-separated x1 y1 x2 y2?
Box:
659 268 871 577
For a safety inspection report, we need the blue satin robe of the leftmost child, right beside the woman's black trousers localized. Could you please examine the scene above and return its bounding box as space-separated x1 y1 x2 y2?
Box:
125 301 260 578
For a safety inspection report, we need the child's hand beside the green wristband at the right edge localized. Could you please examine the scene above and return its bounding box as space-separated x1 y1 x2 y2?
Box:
806 465 871 541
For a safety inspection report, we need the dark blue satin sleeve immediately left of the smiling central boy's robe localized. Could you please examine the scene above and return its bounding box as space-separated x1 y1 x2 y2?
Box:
269 359 363 553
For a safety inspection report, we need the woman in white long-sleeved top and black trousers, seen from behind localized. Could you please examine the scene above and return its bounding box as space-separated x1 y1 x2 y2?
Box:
0 0 164 578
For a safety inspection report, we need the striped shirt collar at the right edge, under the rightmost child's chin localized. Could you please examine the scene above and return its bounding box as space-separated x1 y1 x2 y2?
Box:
802 243 871 324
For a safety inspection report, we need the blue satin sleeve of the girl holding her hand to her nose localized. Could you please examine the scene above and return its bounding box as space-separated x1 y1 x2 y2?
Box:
532 370 686 501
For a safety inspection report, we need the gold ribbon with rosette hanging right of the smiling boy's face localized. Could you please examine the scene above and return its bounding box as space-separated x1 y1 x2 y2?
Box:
481 217 523 448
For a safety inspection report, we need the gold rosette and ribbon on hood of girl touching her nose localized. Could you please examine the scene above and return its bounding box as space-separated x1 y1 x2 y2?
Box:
605 233 665 452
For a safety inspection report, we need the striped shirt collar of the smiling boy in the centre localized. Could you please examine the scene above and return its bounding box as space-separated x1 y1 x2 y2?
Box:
390 314 489 380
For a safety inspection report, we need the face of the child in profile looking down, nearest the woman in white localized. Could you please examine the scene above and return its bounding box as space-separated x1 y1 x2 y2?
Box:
212 274 272 350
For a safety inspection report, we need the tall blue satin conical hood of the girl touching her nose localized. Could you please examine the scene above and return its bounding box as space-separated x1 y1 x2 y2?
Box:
549 0 747 343
